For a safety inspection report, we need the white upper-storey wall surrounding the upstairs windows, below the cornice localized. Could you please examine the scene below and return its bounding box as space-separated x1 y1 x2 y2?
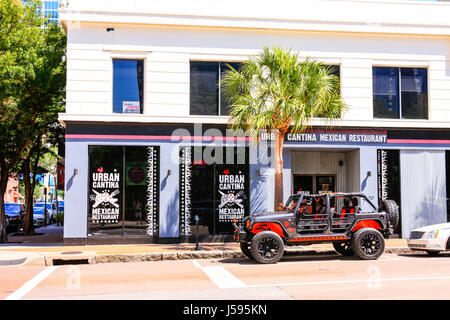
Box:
67 23 450 126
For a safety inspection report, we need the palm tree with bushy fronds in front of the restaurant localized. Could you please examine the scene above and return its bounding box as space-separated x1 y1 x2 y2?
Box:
221 47 346 209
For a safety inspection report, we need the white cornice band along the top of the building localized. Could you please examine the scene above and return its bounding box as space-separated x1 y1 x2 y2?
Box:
60 0 450 36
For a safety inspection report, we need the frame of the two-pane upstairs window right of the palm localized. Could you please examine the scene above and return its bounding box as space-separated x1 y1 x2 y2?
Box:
372 64 430 121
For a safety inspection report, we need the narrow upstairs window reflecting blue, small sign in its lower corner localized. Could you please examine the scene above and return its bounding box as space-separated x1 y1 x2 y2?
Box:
113 59 144 113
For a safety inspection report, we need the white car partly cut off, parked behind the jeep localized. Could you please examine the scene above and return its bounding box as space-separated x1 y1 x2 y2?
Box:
407 223 450 255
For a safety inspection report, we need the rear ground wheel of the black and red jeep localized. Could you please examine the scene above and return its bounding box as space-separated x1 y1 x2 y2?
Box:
351 228 385 260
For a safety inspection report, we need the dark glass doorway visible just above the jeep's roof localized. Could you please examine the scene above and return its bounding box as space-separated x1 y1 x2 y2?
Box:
293 175 336 194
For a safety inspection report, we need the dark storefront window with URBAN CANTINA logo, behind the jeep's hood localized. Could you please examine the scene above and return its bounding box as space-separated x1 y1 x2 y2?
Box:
180 147 250 237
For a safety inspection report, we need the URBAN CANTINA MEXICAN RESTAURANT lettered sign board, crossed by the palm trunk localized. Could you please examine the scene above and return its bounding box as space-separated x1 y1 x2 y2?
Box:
261 129 387 144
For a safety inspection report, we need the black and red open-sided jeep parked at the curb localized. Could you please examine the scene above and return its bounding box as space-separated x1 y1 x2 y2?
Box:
233 193 399 263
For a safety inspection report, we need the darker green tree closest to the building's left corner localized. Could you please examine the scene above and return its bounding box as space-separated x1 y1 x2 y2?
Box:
20 24 66 235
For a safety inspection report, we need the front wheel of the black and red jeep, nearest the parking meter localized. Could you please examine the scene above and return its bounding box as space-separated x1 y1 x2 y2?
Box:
250 231 284 264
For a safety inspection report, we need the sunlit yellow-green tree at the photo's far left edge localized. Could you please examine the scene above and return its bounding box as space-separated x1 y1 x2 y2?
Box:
0 0 44 242
